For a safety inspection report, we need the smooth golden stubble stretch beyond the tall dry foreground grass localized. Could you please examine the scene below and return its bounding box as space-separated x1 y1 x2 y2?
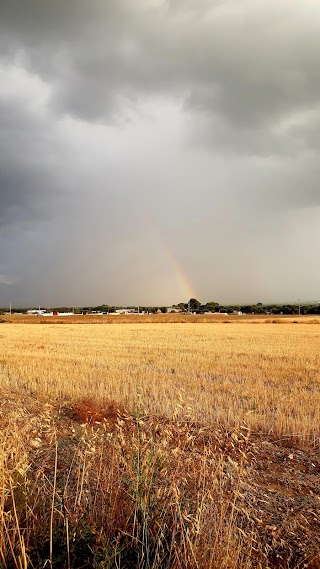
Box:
0 323 320 446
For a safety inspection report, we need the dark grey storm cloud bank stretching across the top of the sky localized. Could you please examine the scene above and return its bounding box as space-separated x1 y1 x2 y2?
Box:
0 0 320 149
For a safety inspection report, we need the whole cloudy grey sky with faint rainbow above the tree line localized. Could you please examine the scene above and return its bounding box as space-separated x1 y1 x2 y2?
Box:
0 0 320 306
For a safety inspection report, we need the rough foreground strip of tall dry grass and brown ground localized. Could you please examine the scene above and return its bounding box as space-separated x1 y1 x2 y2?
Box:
0 391 320 569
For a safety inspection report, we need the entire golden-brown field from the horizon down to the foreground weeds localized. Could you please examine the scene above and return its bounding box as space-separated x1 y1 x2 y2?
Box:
0 315 320 569
